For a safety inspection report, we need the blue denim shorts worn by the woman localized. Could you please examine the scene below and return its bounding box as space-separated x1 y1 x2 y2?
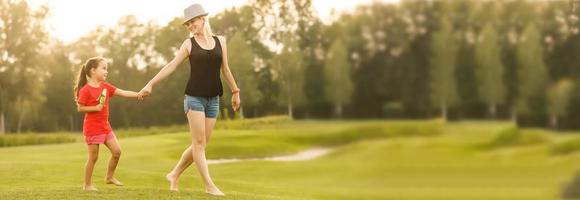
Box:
183 95 220 118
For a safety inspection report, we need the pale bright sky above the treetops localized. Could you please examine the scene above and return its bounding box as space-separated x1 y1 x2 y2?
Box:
27 0 399 43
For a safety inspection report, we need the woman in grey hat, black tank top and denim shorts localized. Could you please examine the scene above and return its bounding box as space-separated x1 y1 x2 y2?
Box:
139 4 240 196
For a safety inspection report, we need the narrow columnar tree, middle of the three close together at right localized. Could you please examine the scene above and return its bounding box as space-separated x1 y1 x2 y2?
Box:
475 23 506 118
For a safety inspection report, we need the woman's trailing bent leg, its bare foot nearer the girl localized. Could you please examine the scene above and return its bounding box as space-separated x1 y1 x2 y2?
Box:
165 115 216 191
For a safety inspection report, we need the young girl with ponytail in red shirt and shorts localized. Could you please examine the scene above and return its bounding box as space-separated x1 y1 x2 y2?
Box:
74 57 137 191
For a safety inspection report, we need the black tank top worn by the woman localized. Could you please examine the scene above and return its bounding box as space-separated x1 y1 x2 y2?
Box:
185 36 223 97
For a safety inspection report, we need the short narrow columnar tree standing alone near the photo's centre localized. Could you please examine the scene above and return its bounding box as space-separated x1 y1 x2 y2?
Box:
324 38 353 117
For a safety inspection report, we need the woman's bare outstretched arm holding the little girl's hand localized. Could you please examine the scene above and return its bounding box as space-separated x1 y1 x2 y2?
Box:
138 39 191 98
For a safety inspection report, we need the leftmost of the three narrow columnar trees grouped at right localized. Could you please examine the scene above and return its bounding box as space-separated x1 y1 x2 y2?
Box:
429 17 458 119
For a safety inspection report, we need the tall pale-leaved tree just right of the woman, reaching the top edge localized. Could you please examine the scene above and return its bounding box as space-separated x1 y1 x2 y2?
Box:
250 0 312 116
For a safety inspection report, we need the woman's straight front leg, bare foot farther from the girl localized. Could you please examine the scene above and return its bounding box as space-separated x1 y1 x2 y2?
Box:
187 110 223 195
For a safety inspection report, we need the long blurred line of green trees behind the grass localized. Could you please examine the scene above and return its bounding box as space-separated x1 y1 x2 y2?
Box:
0 0 580 133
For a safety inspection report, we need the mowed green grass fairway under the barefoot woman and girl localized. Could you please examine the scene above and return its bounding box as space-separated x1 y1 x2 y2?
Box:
0 120 580 200
